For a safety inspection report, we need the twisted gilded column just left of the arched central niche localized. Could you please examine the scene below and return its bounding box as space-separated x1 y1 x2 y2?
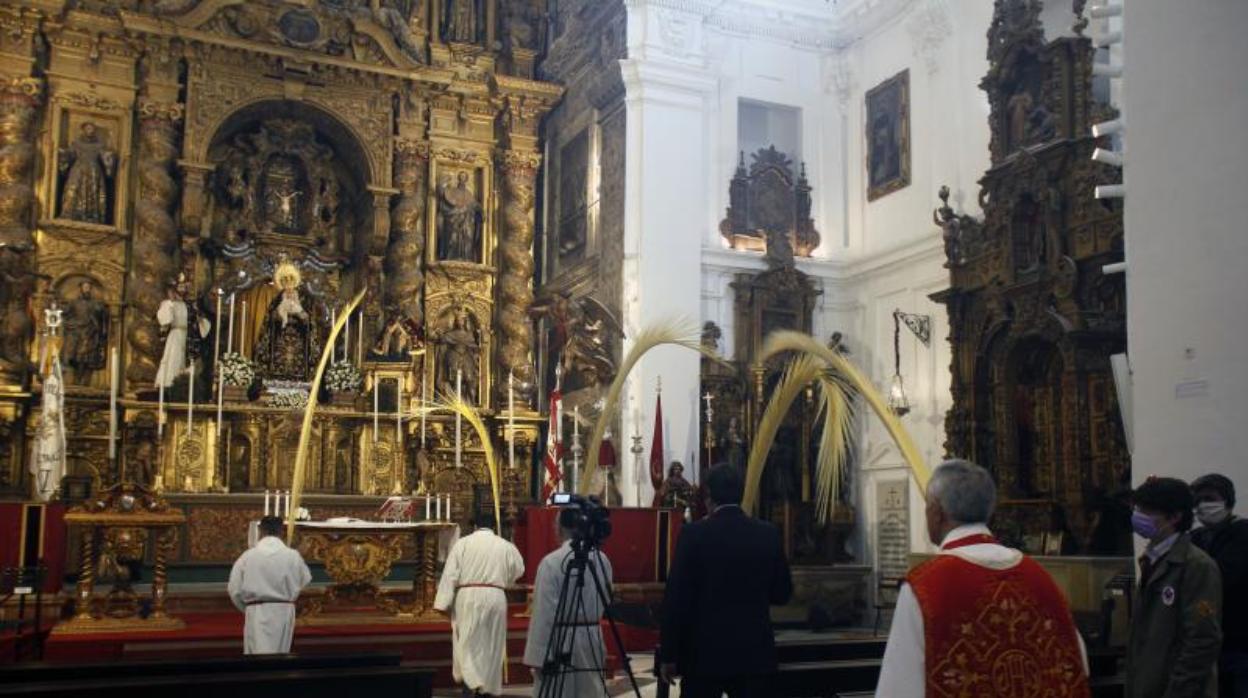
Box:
126 101 182 387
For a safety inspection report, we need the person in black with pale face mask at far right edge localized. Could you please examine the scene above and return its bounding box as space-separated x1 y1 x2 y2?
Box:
1192 474 1248 698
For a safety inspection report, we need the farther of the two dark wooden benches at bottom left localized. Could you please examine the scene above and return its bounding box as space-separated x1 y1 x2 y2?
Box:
0 653 402 684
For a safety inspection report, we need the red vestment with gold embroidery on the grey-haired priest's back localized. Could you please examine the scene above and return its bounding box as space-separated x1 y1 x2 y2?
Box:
906 549 1090 698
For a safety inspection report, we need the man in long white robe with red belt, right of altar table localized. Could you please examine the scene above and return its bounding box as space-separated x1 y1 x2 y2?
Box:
433 511 524 696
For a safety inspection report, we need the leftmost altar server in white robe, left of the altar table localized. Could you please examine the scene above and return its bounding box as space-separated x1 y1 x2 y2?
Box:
230 516 312 654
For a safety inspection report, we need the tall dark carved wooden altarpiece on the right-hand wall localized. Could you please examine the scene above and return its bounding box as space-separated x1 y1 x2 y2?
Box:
932 0 1131 554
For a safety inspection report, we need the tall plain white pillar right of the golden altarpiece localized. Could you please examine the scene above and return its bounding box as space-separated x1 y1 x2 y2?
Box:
615 0 718 504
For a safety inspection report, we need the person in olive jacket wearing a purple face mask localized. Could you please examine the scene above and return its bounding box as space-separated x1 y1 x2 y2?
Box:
1126 477 1222 698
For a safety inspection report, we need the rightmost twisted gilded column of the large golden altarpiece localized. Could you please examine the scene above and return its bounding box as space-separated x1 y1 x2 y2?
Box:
497 150 542 407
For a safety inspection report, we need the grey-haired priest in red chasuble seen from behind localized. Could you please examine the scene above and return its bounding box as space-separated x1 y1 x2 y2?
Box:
876 461 1090 698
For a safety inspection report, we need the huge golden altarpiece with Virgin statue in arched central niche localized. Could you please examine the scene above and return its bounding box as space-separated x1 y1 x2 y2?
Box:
0 0 562 562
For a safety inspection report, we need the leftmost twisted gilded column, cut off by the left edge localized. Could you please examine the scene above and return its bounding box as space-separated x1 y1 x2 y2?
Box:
0 76 42 385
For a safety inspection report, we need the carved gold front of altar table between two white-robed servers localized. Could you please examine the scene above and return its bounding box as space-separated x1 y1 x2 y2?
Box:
295 522 458 624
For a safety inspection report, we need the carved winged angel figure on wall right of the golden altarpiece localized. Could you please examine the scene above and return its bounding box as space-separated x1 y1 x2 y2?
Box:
529 292 624 386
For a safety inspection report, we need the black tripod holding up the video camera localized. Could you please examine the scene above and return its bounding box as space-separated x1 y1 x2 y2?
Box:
538 539 641 698
